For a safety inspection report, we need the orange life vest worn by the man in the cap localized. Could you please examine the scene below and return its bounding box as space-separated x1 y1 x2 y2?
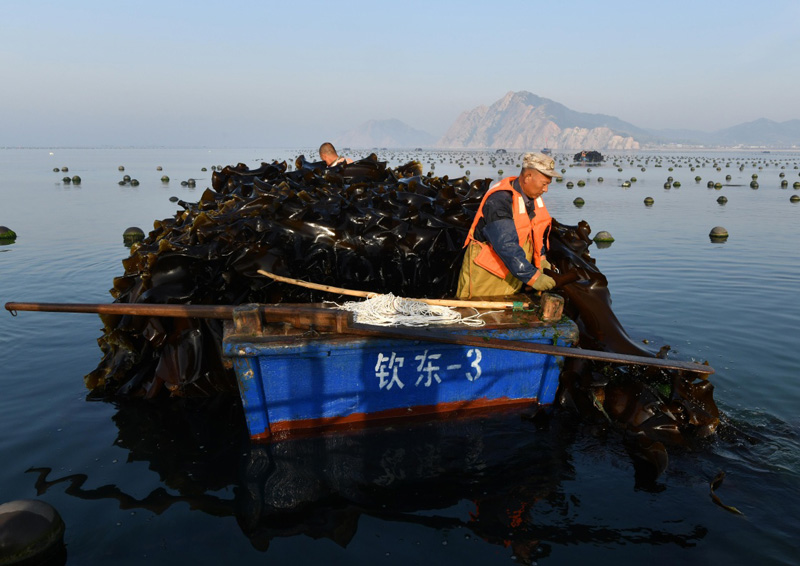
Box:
464 177 552 279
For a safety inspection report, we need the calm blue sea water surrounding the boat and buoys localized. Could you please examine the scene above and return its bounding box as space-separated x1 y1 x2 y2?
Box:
0 148 800 565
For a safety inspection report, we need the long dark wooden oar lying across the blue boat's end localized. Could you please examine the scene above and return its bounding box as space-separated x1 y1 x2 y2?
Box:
0 302 714 375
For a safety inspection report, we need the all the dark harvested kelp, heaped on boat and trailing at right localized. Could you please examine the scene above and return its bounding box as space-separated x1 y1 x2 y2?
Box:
86 150 718 466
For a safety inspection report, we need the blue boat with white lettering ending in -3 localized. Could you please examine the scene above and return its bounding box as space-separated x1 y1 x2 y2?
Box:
223 305 578 441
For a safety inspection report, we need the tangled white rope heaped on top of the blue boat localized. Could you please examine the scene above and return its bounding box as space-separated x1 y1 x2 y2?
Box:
336 293 495 326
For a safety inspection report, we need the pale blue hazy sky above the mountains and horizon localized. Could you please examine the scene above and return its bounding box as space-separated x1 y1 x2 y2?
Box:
6 0 800 147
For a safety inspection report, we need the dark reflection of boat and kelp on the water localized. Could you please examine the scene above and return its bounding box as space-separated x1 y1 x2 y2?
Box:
29 398 706 564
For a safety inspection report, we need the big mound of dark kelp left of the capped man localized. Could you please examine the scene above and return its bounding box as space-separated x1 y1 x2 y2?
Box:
86 155 482 397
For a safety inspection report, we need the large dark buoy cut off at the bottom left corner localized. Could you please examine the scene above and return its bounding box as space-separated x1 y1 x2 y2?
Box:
0 499 66 564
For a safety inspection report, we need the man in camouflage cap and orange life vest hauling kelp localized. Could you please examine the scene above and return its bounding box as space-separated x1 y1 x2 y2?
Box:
457 153 561 299
